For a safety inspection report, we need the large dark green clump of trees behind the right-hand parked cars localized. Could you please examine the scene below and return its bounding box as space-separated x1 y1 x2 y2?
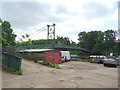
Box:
78 30 120 55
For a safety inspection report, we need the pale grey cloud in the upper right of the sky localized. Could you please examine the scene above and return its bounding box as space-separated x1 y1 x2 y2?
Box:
82 2 114 19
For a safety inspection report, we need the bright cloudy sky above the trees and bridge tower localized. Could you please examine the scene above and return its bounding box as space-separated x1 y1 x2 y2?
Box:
0 0 119 42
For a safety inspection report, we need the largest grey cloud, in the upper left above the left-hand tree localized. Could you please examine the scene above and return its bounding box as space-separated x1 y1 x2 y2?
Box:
2 2 62 29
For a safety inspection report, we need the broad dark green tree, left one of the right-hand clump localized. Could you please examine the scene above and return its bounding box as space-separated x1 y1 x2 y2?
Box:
78 31 104 54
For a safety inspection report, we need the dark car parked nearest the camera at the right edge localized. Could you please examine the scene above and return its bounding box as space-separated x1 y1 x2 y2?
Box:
103 58 119 67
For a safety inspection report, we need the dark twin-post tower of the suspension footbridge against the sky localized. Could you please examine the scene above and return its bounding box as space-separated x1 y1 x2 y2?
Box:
47 23 55 46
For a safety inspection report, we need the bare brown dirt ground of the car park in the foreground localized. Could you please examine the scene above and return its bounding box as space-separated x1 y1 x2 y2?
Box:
2 60 118 88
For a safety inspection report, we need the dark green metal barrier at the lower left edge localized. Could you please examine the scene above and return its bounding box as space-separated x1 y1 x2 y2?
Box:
2 53 22 71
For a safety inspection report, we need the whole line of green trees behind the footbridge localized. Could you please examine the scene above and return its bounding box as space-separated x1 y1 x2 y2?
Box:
0 19 120 55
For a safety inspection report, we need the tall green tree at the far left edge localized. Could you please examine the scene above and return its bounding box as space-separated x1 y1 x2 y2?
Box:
1 21 17 46
